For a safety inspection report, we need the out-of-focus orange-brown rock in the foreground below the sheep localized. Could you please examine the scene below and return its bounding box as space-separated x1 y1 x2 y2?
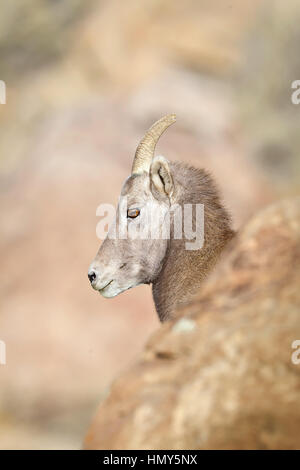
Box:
85 198 300 449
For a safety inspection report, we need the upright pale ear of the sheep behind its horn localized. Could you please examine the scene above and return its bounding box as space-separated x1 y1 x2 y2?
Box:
150 157 174 197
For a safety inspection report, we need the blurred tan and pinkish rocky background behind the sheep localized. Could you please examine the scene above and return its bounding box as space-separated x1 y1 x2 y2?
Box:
0 0 300 449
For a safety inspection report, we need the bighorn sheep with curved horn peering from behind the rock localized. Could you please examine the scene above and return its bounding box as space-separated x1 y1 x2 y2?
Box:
88 114 234 321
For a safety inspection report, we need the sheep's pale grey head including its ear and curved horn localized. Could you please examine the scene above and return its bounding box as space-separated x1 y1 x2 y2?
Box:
88 114 176 297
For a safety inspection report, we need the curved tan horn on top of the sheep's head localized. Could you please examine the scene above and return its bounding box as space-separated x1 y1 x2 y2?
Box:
131 114 176 174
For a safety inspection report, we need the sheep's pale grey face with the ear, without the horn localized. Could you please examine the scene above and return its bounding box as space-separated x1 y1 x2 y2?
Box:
89 157 174 298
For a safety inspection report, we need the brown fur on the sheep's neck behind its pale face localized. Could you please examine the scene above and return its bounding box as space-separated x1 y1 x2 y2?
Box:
152 163 234 321
